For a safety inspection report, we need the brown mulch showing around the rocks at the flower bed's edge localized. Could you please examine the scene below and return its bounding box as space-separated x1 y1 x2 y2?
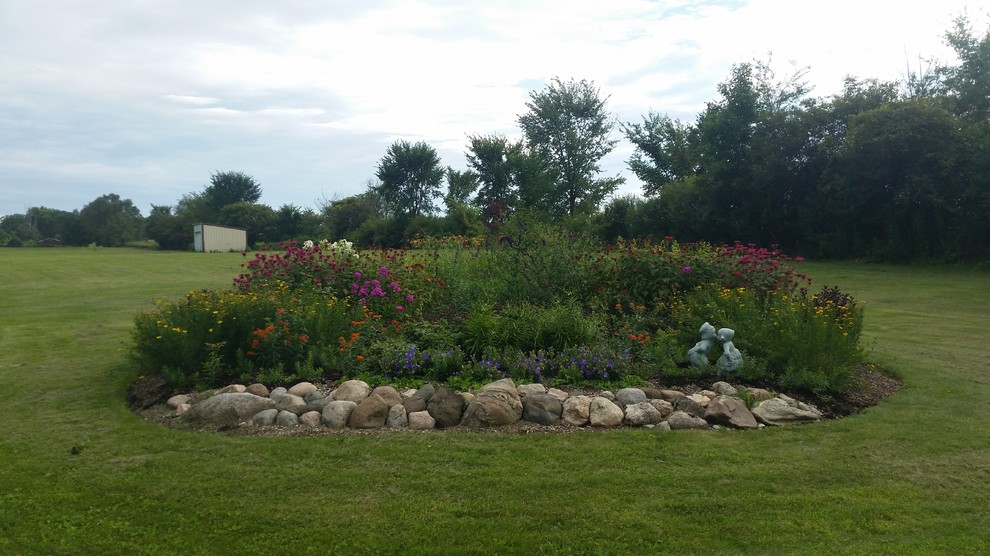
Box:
134 364 902 436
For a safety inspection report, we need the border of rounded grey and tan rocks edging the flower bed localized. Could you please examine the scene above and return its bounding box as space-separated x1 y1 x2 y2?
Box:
155 378 823 435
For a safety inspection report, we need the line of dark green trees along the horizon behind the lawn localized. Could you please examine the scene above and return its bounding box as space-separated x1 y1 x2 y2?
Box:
0 17 990 261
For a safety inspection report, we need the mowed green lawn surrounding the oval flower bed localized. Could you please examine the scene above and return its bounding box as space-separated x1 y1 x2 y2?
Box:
0 248 990 554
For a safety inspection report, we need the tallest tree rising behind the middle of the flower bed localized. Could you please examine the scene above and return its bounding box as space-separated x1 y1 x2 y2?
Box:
518 78 624 215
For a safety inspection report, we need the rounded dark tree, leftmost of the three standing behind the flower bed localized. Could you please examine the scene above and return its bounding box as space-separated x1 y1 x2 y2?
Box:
372 139 444 217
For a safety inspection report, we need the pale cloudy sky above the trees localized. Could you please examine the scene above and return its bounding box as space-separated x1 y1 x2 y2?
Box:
0 0 988 216
